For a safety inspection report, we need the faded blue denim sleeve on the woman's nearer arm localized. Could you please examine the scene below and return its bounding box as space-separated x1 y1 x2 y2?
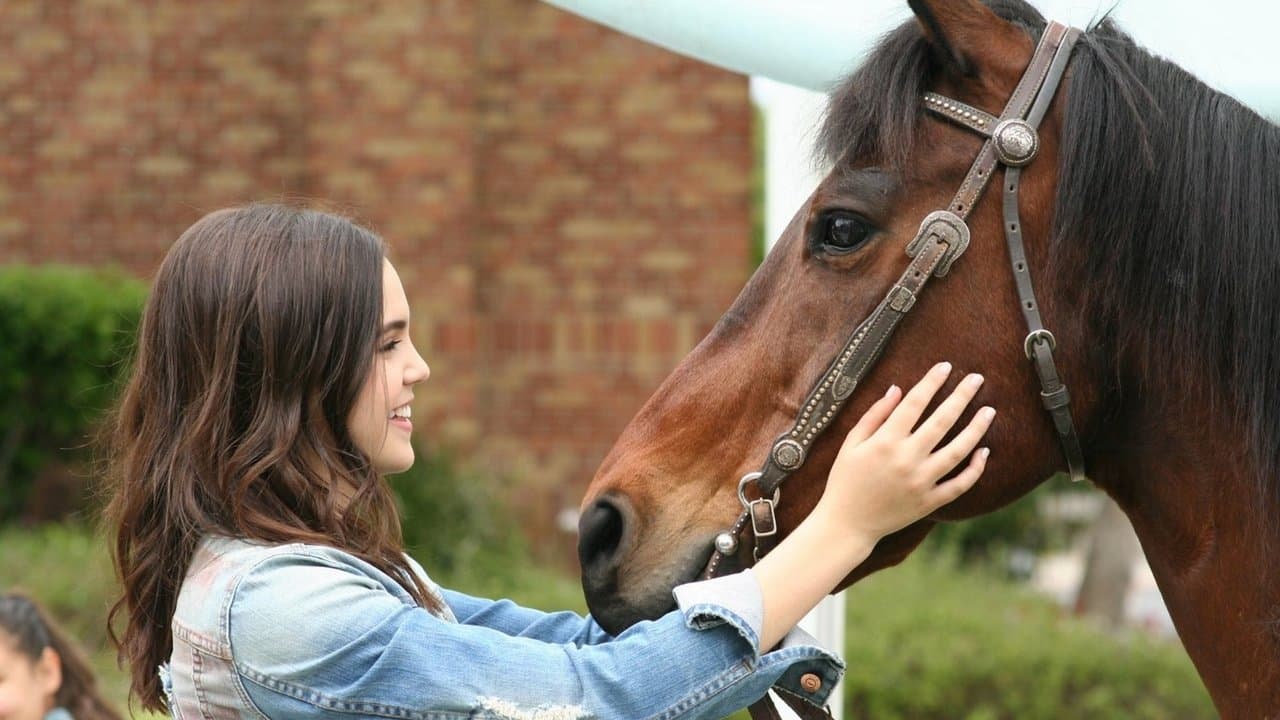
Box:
227 553 838 720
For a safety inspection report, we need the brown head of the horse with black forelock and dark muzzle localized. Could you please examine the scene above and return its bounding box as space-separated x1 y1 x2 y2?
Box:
580 1 1096 630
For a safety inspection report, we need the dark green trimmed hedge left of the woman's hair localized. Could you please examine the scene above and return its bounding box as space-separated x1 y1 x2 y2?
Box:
0 260 146 523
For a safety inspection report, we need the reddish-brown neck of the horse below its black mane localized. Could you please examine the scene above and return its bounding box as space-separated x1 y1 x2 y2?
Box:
1093 388 1280 717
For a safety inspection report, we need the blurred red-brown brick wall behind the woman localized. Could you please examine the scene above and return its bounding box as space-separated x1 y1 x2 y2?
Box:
0 0 750 556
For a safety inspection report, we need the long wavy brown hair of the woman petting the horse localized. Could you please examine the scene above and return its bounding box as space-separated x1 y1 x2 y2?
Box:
105 204 438 710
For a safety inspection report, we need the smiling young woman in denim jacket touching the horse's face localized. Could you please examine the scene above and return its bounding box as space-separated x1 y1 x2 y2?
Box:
109 205 993 720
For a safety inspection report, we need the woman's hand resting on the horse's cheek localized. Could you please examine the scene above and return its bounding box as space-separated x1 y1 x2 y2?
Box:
814 363 996 542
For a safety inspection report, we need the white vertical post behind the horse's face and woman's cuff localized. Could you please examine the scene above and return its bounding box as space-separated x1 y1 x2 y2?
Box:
751 77 845 720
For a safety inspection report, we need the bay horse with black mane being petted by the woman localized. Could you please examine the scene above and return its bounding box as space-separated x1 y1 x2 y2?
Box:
579 0 1280 719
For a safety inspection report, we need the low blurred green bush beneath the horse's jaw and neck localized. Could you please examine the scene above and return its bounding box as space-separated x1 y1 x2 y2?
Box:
844 553 1216 720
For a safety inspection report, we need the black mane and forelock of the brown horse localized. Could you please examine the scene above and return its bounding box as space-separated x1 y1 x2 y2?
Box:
817 0 1280 501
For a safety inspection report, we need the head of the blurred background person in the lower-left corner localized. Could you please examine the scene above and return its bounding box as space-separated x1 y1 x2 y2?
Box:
0 592 119 720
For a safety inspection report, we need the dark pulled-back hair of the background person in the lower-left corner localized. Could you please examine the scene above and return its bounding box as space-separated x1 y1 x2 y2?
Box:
0 592 120 720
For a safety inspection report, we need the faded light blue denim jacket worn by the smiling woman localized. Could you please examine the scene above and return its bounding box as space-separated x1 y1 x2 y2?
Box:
160 537 844 720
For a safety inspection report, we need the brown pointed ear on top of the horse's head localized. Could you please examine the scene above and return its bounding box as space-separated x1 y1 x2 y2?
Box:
908 0 1030 78
